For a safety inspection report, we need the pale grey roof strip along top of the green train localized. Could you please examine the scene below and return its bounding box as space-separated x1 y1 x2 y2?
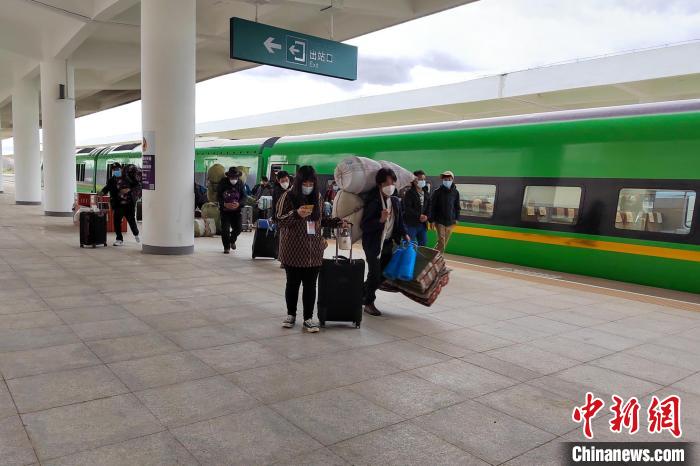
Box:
272 99 700 143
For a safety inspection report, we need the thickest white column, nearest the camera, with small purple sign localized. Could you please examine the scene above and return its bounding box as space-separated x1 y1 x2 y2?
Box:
141 0 196 254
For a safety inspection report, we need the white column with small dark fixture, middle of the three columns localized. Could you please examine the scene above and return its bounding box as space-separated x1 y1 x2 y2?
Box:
40 59 75 217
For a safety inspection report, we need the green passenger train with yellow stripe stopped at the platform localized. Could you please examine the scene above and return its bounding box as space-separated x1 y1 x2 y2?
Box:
76 100 700 293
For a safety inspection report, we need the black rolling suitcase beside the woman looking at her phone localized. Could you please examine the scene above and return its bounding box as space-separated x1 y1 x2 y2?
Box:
318 228 365 328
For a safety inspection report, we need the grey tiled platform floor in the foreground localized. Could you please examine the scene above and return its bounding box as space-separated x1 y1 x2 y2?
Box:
0 186 700 466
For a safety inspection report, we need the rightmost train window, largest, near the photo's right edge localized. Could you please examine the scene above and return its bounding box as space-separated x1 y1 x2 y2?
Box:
615 188 696 235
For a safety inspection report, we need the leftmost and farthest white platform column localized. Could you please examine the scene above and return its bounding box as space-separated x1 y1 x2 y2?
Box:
12 79 41 205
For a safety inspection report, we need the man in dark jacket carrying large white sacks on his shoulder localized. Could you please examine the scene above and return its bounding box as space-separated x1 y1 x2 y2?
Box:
361 168 410 316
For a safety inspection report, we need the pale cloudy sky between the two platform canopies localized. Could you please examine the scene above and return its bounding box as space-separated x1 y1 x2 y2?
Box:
5 0 700 153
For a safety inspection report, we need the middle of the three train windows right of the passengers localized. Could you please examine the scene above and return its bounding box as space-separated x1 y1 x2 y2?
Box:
522 186 582 225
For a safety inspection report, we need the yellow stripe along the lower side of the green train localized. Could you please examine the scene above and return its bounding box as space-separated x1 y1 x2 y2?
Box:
454 226 700 262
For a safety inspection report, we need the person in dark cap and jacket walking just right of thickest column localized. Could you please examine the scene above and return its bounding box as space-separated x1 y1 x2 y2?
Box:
217 167 246 254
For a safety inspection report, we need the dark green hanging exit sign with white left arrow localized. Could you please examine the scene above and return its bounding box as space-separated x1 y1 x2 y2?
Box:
231 18 357 81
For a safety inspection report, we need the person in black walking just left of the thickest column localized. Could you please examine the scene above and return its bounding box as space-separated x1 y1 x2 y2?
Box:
102 162 141 246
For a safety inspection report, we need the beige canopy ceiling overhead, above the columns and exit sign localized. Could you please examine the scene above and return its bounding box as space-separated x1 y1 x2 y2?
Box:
0 0 475 137
